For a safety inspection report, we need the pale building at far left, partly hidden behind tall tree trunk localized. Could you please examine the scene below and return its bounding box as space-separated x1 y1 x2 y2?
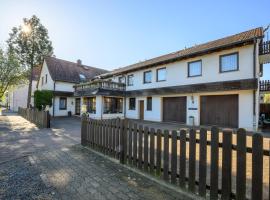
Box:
7 67 41 112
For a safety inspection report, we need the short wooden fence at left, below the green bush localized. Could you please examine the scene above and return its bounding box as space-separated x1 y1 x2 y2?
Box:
18 107 50 128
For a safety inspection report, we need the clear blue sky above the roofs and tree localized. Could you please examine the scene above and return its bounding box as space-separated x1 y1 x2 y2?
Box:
0 0 270 79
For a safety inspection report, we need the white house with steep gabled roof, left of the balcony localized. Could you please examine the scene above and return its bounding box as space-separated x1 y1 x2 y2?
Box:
37 57 107 116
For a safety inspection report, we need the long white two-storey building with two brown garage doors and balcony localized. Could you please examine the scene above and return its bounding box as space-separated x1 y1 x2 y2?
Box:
74 28 265 130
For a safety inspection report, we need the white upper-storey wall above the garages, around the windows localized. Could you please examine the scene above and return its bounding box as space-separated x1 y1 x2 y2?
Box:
113 45 259 90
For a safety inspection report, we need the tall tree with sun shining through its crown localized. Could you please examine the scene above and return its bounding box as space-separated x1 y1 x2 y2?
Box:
7 15 53 107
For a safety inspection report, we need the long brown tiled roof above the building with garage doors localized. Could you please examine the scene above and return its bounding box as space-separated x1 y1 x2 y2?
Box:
102 27 263 77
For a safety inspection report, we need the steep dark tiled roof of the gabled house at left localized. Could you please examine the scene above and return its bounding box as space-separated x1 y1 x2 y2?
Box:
44 57 108 83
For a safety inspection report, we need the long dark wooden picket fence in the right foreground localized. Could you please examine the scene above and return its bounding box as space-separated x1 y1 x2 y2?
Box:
81 117 270 200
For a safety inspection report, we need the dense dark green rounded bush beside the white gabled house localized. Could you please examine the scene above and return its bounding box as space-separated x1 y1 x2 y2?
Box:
34 90 53 110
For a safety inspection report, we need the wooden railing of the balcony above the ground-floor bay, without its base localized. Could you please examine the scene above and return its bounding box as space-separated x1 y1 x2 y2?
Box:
74 80 126 92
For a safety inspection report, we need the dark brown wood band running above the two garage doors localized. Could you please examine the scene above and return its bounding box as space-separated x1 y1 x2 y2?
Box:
126 79 258 97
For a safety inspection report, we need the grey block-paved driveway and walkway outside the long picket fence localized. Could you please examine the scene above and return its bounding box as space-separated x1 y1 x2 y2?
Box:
0 115 192 200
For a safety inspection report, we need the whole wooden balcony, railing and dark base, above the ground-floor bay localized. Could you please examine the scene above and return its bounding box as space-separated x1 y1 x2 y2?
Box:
74 80 126 96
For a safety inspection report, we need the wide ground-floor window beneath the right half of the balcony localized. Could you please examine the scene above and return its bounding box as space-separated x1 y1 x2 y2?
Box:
103 97 123 114
